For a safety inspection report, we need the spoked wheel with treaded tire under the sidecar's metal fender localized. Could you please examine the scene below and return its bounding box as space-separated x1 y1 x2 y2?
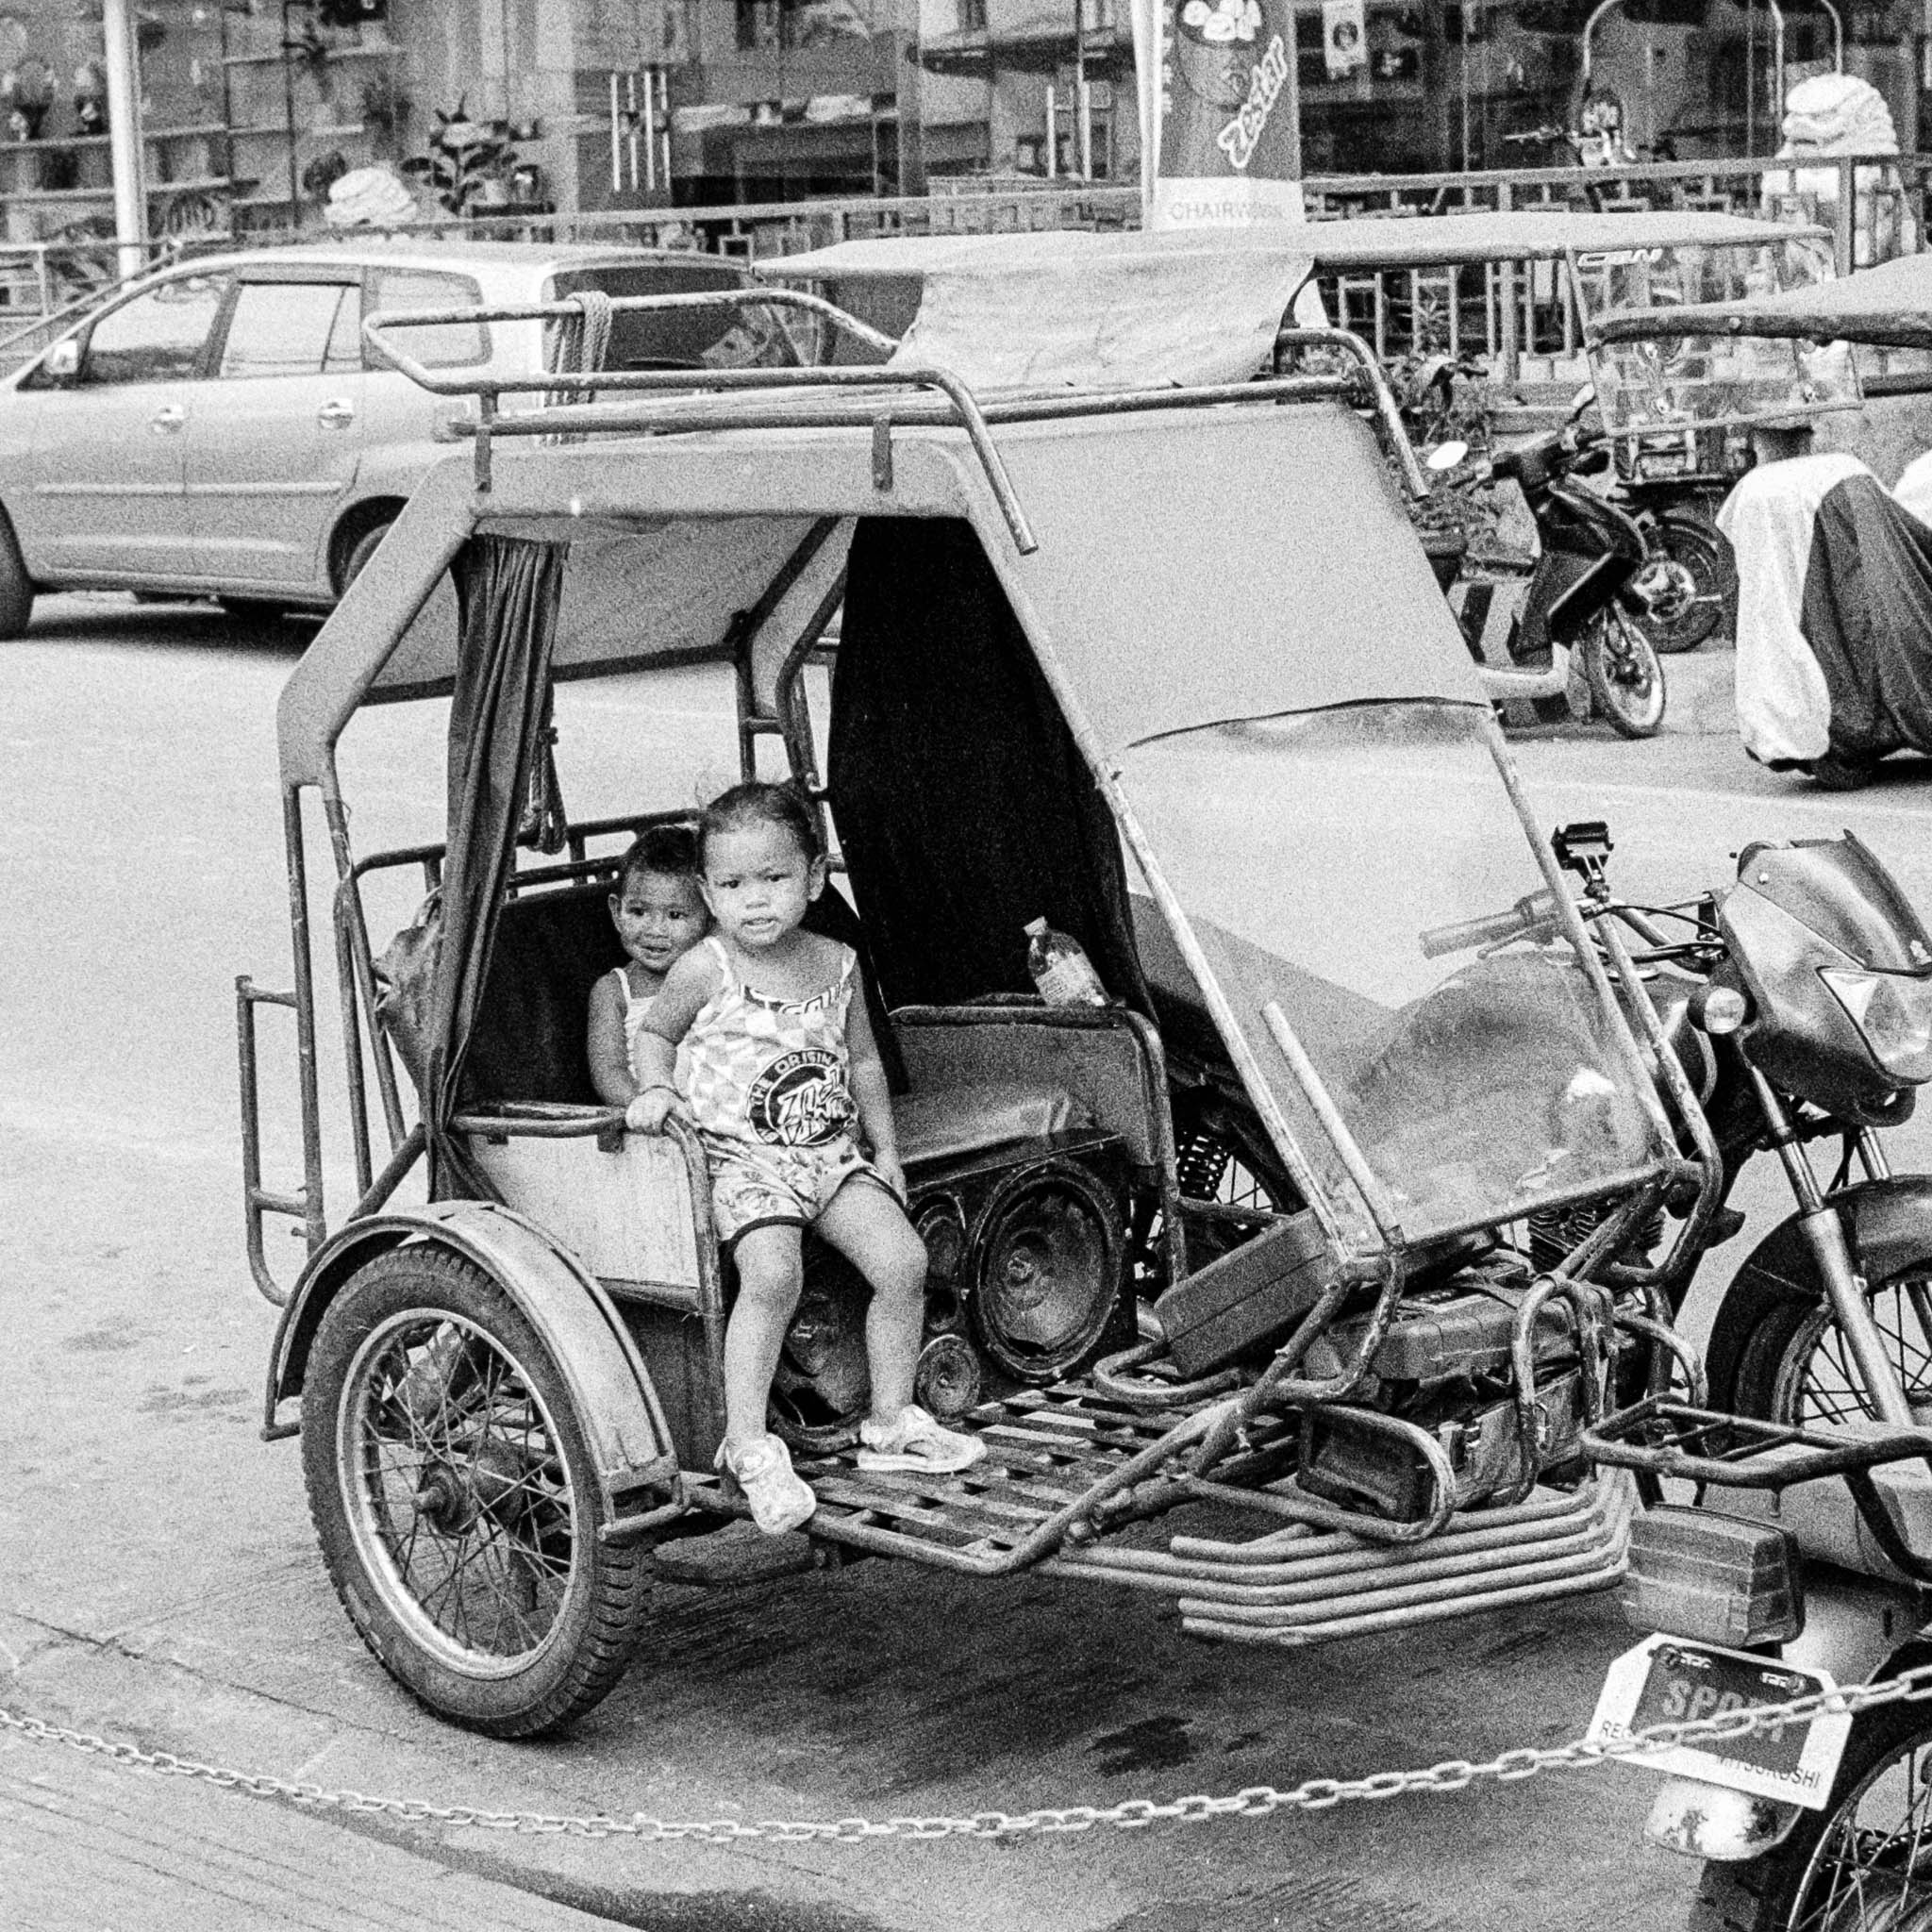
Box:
301 1244 649 1737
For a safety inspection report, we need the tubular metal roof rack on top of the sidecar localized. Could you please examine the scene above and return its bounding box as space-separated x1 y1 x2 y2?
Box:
361 288 1430 557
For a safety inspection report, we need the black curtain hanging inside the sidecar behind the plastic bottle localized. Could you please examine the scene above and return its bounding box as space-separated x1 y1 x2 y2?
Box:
827 518 1152 1014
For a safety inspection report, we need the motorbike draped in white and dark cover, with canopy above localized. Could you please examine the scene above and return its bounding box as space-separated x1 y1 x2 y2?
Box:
1598 255 1932 789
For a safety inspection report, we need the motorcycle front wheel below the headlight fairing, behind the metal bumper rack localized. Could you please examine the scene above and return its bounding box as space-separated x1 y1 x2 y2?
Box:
1709 1254 1932 1430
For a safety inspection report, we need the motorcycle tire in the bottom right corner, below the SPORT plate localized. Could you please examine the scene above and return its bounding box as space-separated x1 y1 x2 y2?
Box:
1690 1704 1932 1932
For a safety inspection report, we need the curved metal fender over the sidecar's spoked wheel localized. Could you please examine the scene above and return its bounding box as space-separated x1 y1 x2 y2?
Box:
267 1200 678 1507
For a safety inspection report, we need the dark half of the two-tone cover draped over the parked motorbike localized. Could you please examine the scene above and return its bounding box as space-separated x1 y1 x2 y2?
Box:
1799 475 1932 763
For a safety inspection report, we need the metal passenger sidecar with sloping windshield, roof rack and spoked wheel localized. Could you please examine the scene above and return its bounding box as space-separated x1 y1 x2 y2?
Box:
242 233 1716 1735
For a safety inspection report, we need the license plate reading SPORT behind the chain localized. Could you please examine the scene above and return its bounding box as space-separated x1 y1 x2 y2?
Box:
1591 1633 1851 1810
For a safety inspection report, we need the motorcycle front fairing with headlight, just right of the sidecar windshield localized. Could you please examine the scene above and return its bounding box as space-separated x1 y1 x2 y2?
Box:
1718 833 1932 1121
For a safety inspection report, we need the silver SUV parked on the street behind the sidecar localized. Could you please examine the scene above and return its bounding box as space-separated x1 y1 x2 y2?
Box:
0 240 798 638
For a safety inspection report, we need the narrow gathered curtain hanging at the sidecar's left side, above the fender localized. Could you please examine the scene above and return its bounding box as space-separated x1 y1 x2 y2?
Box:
425 537 566 1200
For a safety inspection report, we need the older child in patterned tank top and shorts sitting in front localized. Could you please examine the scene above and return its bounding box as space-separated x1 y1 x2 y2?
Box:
628 784 983 1534
